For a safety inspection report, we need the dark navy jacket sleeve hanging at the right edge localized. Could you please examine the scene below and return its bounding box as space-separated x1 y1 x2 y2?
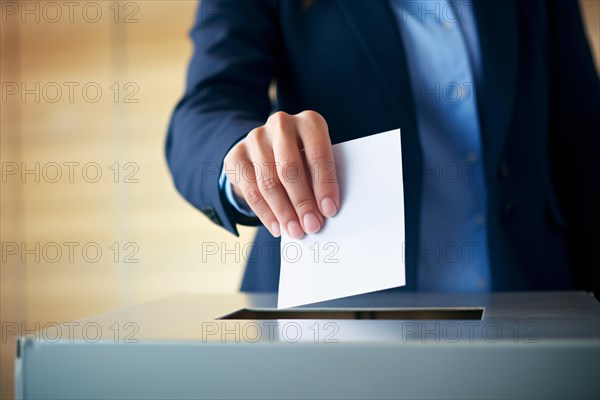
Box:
547 0 600 298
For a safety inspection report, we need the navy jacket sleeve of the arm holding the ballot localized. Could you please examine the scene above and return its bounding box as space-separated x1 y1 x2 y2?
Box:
166 0 281 235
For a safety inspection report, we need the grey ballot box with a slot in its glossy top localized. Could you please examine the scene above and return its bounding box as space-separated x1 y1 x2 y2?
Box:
16 291 600 399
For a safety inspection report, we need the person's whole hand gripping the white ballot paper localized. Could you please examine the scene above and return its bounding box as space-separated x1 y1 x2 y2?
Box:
225 111 340 239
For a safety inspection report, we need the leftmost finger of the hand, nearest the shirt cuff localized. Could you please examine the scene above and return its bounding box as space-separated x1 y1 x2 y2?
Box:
225 146 281 237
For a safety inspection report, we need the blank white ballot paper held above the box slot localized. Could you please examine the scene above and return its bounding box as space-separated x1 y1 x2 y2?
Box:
277 129 406 308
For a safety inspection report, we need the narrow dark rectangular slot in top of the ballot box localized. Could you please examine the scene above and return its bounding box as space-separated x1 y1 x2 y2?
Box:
217 308 483 320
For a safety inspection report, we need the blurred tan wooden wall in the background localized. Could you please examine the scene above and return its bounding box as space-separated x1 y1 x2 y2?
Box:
0 0 600 399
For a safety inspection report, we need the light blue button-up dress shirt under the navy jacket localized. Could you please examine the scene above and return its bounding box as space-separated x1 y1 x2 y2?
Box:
220 0 491 291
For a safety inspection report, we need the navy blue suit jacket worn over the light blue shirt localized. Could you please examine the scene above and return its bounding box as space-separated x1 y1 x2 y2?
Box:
166 0 600 292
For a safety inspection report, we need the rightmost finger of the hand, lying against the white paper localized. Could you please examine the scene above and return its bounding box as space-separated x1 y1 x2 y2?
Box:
298 111 340 218
